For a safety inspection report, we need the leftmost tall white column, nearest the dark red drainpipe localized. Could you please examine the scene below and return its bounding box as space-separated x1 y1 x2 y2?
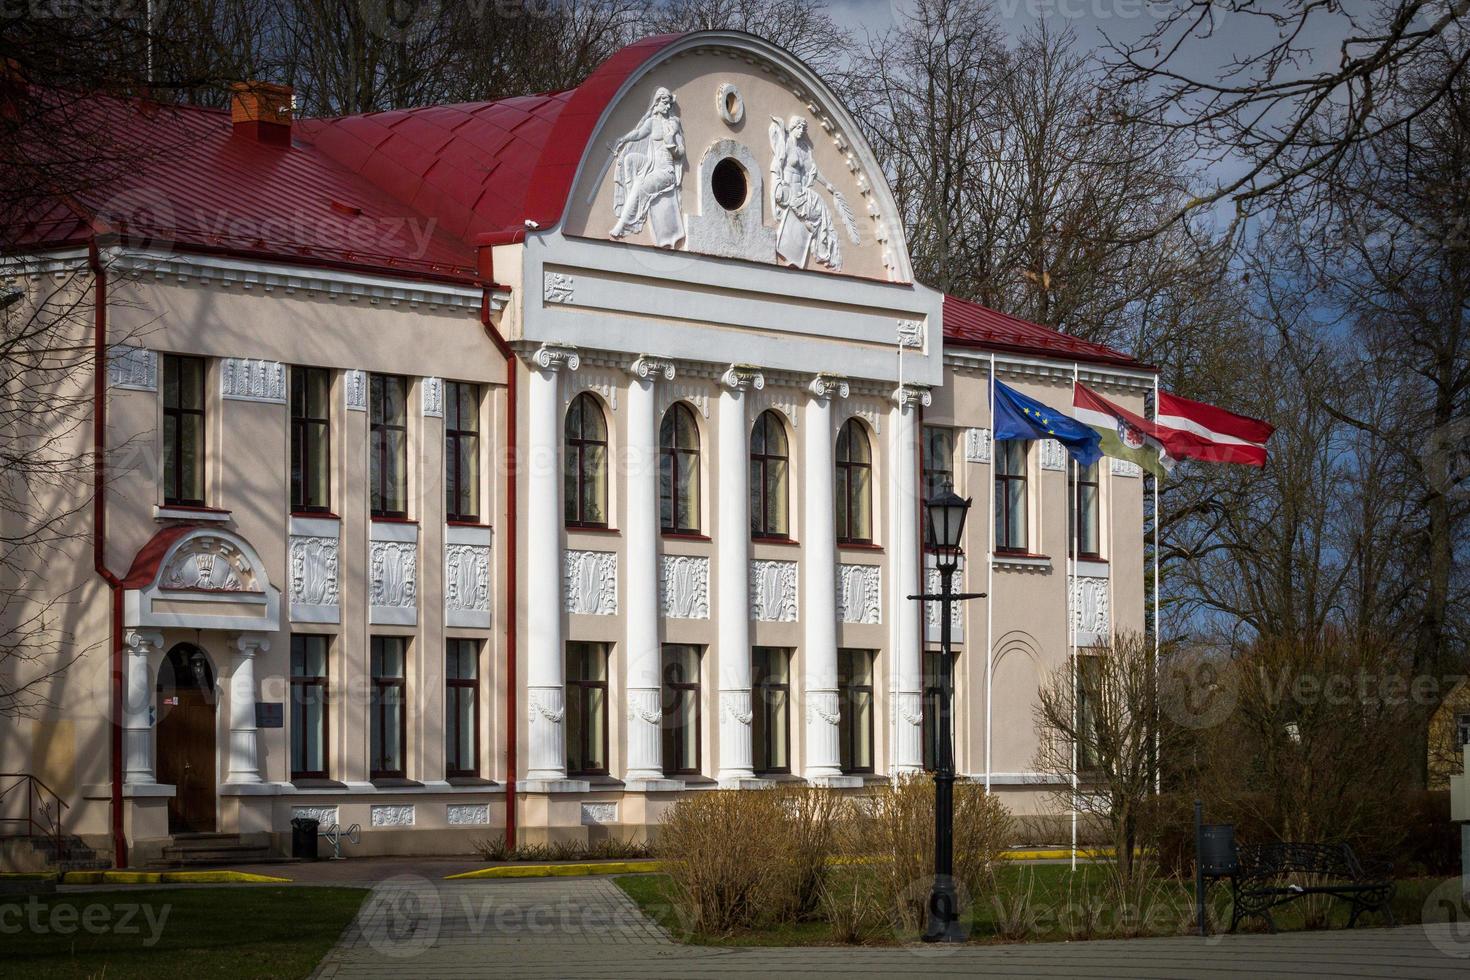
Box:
525 344 581 782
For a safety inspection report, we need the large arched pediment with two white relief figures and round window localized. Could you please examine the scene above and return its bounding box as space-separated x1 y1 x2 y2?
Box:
563 31 913 282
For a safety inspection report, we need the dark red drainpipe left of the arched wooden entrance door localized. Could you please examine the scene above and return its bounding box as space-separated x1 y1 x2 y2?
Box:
87 234 128 868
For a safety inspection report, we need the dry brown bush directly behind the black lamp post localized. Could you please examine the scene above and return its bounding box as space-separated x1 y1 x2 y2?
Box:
853 774 1011 932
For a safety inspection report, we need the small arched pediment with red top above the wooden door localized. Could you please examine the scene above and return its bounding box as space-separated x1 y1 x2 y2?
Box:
123 525 281 632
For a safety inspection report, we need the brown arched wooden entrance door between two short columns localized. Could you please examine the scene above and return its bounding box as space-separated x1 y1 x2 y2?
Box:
159 688 215 833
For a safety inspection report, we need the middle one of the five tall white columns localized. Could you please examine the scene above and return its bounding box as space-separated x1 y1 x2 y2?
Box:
714 364 766 788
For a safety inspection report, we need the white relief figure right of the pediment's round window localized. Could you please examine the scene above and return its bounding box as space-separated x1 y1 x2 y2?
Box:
770 116 863 269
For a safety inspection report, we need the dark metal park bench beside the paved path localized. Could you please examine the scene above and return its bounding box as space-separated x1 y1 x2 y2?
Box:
1230 843 1395 933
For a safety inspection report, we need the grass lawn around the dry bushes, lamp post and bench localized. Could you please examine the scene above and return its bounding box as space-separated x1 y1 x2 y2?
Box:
614 864 1441 946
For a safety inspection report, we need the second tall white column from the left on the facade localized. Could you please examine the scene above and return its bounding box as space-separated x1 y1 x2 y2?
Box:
623 357 673 783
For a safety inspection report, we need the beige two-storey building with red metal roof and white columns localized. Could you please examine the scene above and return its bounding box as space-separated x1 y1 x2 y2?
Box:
0 32 1155 864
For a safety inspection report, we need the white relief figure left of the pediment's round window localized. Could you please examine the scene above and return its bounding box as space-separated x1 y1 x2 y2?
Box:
610 88 684 248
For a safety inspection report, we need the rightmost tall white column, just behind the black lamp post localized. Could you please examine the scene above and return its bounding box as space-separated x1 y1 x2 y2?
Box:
888 385 931 774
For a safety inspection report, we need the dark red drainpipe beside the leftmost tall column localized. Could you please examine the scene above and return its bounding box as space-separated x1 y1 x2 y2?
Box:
475 229 525 851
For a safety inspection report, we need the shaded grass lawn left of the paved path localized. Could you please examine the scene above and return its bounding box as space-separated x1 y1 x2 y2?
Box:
0 886 368 980
